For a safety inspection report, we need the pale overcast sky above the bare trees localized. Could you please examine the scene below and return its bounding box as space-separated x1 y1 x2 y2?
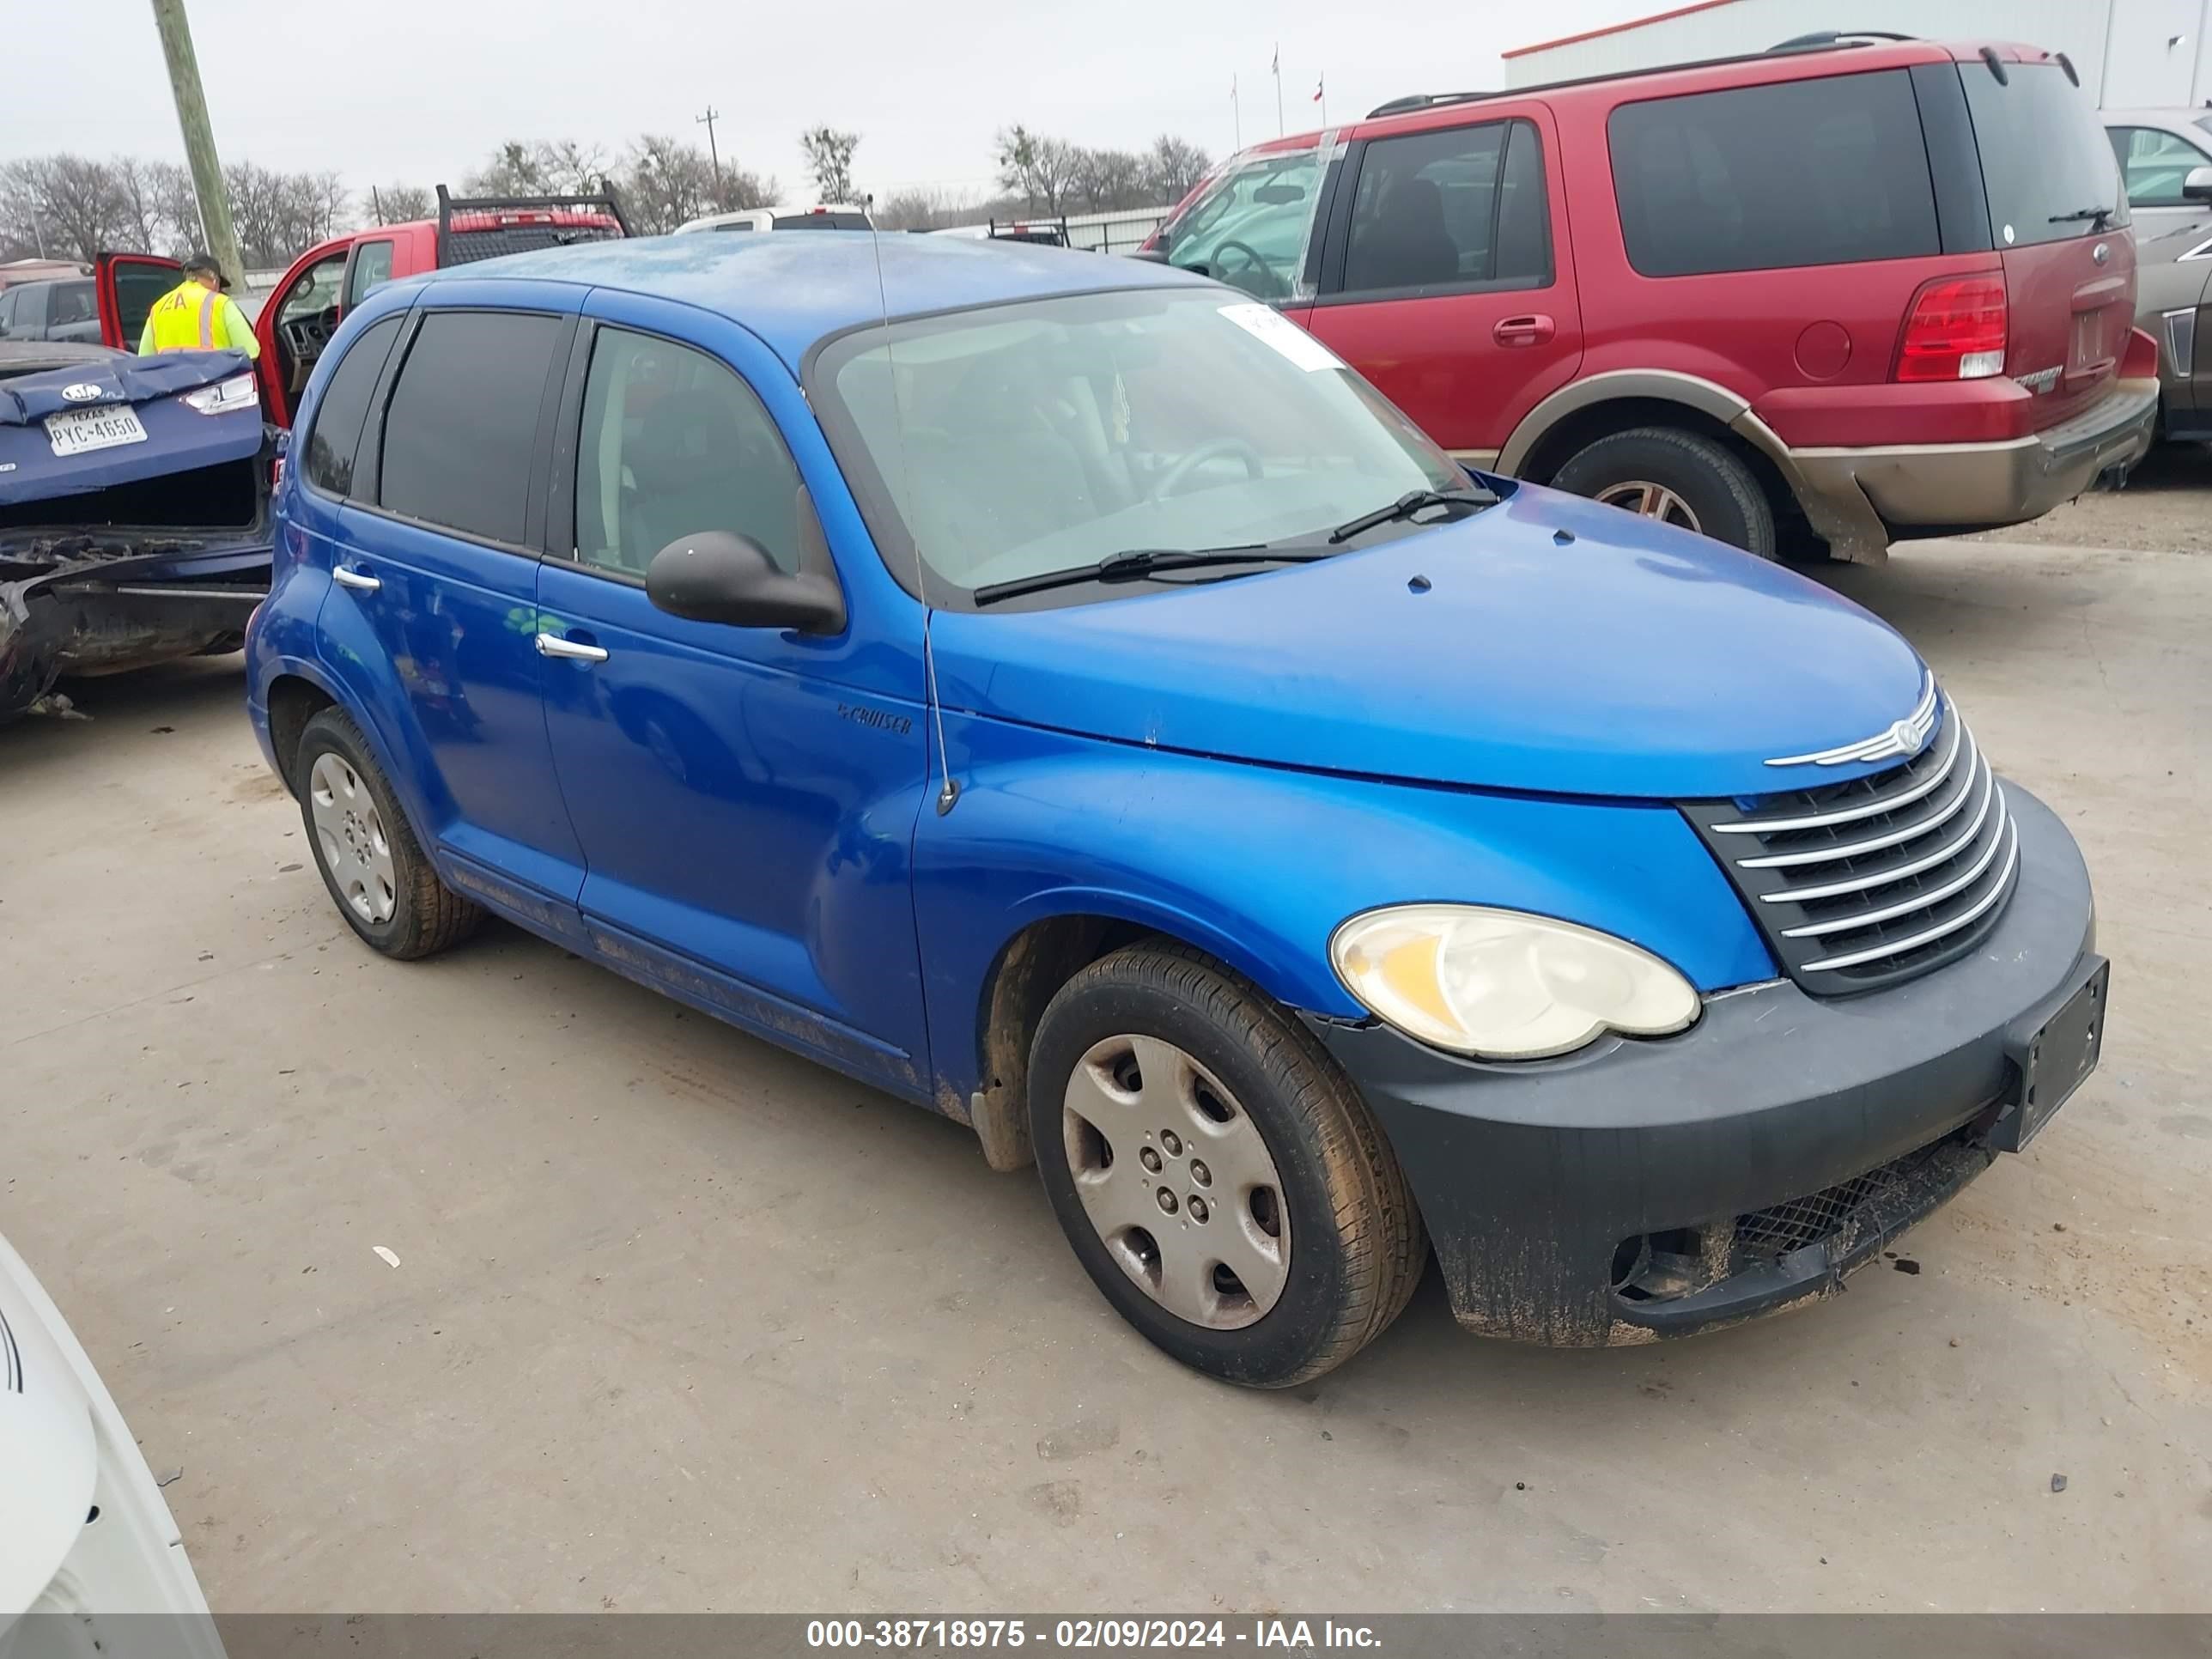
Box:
13 0 1666 206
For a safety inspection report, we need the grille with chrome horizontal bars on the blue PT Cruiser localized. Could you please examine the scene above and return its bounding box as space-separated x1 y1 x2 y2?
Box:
1683 702 2020 995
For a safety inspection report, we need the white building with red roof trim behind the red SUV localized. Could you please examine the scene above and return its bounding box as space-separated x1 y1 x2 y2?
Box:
1502 0 2212 108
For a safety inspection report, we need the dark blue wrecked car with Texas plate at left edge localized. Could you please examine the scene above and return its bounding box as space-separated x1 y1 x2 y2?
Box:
0 341 274 721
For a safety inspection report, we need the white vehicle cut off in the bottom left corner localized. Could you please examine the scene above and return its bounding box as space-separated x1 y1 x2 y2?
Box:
0 1239 223 1659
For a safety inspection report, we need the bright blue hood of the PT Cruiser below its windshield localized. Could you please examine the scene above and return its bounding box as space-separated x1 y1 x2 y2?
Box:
931 480 1927 799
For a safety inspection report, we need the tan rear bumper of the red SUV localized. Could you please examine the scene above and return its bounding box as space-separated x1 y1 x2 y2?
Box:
1787 378 2159 560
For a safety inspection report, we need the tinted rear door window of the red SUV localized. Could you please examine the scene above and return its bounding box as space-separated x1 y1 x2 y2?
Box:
1343 122 1551 295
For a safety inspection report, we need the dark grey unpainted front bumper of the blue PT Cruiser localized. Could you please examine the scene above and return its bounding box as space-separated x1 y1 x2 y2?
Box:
1312 785 2101 1347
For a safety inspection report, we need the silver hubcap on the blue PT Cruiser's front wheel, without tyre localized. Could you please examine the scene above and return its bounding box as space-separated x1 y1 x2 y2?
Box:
1061 1037 1290 1332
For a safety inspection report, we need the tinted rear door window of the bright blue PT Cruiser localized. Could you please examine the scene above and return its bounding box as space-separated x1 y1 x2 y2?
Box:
378 312 560 546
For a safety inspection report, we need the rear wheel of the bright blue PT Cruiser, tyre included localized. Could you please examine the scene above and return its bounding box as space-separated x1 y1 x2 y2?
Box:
292 708 484 960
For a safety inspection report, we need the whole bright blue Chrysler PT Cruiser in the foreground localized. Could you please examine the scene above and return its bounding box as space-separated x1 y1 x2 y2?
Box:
248 234 2106 1387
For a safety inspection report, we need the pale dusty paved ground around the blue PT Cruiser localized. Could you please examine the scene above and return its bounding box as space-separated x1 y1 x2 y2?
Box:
0 539 2212 1613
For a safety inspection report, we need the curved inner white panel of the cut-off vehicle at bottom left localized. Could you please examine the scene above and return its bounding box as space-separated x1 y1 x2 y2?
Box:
0 1239 100 1624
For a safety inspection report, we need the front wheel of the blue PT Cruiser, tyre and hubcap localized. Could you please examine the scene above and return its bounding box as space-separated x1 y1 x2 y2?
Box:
1029 942 1427 1387
